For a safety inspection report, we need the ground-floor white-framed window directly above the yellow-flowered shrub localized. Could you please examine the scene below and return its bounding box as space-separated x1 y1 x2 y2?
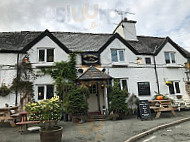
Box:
38 85 54 100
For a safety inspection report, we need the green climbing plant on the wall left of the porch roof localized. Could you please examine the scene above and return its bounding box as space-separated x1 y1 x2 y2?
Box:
41 53 77 100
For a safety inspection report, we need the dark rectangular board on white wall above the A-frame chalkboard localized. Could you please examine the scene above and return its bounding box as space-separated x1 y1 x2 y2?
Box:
138 82 150 96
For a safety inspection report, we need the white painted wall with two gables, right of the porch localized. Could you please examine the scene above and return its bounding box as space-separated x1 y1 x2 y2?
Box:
100 39 189 99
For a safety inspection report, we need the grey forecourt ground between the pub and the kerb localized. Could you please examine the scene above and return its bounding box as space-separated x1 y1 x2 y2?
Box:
0 111 190 142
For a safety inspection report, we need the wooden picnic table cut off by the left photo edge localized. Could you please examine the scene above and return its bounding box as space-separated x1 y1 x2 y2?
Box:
0 106 19 127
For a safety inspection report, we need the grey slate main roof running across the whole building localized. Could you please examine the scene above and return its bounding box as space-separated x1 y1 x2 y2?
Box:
0 30 190 57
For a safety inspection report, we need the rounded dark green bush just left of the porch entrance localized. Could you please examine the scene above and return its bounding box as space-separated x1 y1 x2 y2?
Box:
64 87 90 115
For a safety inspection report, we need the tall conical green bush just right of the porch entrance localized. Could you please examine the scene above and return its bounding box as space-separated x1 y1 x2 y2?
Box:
109 81 128 115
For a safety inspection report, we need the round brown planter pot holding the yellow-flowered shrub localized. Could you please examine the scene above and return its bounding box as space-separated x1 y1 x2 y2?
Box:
40 126 63 142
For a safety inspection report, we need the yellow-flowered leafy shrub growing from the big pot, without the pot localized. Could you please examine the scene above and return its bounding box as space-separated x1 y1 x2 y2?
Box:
25 96 63 129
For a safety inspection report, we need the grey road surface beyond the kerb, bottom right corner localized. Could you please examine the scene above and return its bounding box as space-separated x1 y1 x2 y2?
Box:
137 121 190 142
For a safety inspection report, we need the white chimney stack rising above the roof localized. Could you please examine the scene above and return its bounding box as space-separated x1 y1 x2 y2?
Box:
113 18 138 41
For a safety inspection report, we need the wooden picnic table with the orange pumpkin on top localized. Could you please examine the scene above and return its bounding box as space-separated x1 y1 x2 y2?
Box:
149 100 176 118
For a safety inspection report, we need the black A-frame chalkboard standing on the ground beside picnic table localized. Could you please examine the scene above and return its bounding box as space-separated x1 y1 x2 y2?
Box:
138 100 151 120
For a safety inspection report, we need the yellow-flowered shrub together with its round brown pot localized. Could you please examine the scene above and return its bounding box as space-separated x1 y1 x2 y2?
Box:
25 96 63 142
